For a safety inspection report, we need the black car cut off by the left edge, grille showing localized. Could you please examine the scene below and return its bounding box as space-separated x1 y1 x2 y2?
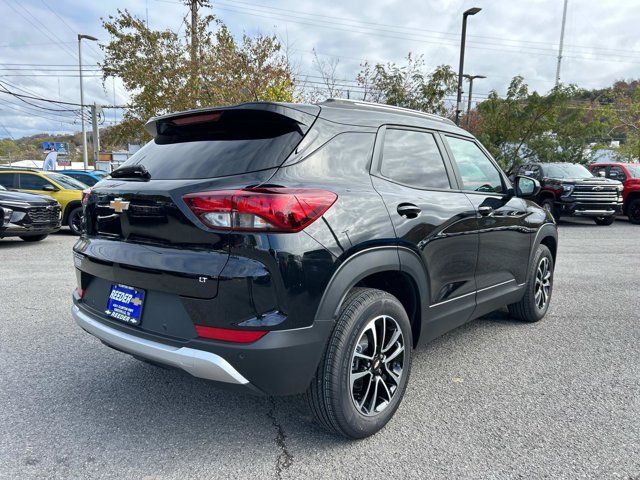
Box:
0 185 61 242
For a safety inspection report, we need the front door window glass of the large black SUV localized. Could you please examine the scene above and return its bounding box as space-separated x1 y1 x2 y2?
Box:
447 136 504 193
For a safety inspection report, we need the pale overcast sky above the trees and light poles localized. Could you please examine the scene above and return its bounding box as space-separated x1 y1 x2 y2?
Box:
0 0 640 138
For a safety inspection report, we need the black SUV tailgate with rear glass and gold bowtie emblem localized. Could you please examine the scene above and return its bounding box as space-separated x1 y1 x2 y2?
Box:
74 104 315 338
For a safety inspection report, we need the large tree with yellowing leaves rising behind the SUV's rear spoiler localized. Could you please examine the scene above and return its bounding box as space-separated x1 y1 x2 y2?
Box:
101 7 294 143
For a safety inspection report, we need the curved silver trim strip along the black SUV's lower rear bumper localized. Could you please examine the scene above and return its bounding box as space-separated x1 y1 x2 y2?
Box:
71 305 249 385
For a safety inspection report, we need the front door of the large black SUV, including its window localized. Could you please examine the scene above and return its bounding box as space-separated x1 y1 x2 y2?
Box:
444 134 536 315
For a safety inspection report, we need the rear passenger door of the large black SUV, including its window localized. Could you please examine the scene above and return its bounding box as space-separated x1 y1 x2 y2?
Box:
372 126 478 337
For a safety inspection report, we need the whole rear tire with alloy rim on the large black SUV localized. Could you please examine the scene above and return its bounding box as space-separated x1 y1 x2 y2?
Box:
305 288 413 439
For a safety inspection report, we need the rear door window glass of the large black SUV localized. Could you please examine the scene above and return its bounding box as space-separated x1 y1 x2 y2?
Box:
380 128 451 188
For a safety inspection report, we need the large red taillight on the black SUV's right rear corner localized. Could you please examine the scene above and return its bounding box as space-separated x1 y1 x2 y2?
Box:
183 188 338 232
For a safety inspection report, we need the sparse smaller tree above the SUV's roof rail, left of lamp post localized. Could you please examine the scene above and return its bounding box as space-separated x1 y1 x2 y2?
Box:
356 53 457 115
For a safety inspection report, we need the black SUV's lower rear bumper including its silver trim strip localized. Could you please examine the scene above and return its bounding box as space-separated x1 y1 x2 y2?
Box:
71 298 333 395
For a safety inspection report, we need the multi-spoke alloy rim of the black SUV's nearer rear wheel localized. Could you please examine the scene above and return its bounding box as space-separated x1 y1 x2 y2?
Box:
349 315 405 416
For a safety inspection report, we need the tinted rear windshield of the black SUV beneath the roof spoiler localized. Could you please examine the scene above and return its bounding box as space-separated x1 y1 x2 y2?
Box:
123 110 304 180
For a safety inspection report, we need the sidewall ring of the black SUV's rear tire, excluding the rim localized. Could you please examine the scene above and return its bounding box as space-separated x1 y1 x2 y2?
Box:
335 295 413 438
